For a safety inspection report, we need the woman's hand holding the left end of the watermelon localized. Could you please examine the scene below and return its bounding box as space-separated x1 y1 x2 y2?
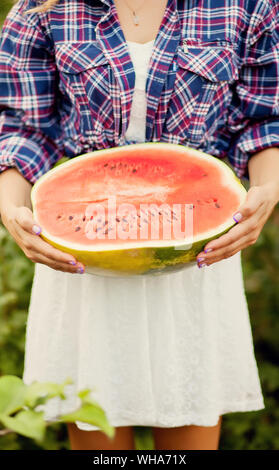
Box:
1 206 84 274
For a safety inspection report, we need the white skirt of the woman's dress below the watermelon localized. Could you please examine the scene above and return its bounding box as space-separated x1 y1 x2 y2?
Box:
23 253 264 430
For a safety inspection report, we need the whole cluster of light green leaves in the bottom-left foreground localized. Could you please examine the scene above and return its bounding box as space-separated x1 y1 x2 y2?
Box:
0 375 115 443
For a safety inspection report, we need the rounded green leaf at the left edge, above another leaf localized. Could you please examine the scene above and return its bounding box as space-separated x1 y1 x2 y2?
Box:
0 375 26 415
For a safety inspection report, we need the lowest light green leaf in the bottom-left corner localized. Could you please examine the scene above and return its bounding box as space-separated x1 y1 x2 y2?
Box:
0 410 46 441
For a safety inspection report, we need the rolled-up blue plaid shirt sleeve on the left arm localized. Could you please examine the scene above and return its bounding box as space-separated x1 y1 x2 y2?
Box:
0 0 63 183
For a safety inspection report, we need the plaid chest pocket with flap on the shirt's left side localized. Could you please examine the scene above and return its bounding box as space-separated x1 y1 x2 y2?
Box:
56 42 113 143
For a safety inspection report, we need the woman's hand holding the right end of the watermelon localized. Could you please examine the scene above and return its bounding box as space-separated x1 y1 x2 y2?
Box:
197 183 279 267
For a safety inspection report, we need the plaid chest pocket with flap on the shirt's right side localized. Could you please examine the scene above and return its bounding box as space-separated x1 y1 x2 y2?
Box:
166 43 238 146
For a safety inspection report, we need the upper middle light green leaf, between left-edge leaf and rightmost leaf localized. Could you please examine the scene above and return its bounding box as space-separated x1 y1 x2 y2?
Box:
24 379 72 408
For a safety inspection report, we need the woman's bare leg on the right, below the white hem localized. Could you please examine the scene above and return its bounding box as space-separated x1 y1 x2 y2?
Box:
153 416 221 450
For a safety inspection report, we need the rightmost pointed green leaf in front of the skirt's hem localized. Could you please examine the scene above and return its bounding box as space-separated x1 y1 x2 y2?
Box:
60 403 115 437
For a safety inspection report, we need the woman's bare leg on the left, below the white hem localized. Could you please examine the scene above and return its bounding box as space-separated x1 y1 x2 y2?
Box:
67 423 135 450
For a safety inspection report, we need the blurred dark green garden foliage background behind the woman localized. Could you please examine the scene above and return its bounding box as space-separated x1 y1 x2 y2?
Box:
0 0 279 450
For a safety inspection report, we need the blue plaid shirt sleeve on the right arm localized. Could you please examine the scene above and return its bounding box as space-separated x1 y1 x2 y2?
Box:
228 0 279 178
